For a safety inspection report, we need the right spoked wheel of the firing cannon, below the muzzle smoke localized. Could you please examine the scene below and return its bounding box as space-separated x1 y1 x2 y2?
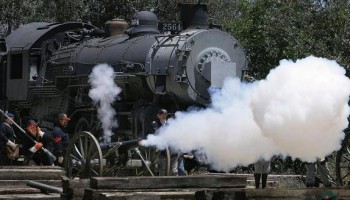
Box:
135 146 170 176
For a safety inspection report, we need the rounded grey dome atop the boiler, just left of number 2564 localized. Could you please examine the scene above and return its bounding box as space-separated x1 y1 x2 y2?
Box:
127 11 159 36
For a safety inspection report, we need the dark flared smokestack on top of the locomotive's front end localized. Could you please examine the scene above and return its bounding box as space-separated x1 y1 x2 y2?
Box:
178 3 209 29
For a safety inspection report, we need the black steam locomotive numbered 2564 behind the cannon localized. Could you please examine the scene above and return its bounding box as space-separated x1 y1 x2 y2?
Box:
0 3 247 141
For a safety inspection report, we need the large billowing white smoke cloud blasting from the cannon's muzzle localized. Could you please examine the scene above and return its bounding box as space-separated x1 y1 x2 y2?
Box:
143 56 350 171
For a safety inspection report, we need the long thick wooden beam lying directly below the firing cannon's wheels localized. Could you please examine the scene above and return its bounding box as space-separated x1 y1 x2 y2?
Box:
90 176 247 189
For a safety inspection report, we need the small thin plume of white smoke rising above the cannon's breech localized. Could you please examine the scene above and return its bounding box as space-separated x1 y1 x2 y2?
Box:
89 64 122 143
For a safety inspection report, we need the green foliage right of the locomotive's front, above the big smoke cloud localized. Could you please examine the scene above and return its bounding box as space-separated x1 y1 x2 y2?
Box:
224 0 350 78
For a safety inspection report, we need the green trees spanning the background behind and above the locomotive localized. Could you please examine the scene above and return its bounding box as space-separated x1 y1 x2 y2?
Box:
0 0 350 78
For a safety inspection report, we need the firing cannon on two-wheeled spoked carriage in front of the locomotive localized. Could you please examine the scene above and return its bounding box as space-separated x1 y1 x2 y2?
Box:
65 131 170 178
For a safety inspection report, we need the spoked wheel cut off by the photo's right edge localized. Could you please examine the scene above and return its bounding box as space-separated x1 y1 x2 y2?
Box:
336 129 350 185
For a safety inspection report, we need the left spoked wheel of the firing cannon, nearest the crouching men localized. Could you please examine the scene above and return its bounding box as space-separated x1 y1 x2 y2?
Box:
65 131 103 178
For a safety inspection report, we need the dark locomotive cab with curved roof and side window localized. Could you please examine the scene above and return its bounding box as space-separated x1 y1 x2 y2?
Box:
2 22 95 118
